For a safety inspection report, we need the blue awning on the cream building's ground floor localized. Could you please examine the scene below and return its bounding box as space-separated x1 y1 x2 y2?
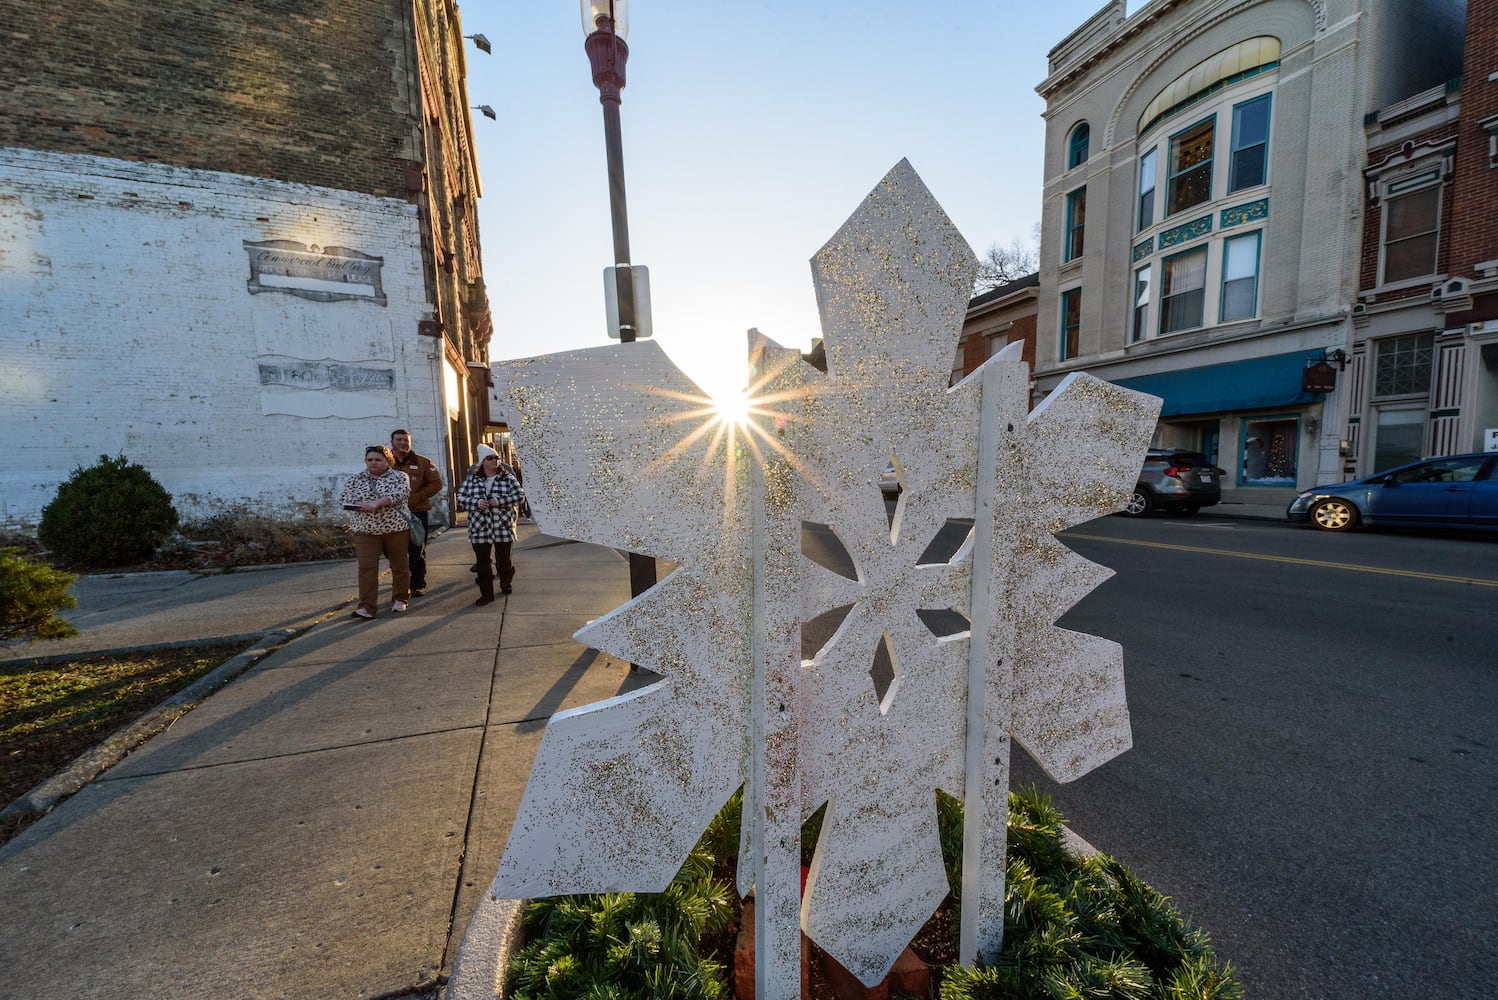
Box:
1115 350 1321 416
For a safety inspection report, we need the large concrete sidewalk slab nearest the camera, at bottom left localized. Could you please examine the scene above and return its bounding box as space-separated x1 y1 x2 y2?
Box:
0 732 479 999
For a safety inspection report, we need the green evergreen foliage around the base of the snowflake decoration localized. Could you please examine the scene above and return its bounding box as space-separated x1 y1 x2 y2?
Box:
509 789 1242 1000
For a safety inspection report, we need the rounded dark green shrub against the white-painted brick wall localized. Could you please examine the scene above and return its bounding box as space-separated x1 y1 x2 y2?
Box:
36 455 177 566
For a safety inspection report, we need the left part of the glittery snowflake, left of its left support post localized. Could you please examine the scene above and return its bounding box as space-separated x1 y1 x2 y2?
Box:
493 343 749 898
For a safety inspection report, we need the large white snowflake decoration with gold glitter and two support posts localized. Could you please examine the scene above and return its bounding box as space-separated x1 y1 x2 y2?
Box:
493 162 1159 999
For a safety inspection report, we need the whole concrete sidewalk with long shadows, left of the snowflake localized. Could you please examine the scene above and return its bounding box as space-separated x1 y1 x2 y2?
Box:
0 527 650 1000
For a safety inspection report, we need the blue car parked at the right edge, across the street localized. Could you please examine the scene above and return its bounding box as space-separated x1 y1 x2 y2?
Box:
1285 452 1498 531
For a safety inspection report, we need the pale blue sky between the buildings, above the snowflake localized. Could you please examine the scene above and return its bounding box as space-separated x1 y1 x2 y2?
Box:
461 0 1104 391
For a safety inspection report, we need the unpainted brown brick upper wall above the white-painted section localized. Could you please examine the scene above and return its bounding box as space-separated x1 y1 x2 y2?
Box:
0 0 419 198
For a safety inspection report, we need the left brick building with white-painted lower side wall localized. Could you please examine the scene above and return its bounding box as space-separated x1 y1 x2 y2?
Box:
0 0 490 525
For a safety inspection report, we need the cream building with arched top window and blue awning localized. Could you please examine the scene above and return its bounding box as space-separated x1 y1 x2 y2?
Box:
1035 0 1465 501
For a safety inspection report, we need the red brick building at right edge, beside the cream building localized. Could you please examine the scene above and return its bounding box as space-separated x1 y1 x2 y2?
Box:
1345 0 1498 475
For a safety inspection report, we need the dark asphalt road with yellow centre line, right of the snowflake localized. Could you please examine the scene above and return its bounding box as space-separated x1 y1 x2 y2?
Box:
803 512 1498 1000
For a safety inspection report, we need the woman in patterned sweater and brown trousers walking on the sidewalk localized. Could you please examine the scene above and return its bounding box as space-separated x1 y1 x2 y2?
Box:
343 445 410 621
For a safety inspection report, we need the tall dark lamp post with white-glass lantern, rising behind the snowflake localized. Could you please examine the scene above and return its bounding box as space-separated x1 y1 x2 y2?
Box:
581 0 656 610
